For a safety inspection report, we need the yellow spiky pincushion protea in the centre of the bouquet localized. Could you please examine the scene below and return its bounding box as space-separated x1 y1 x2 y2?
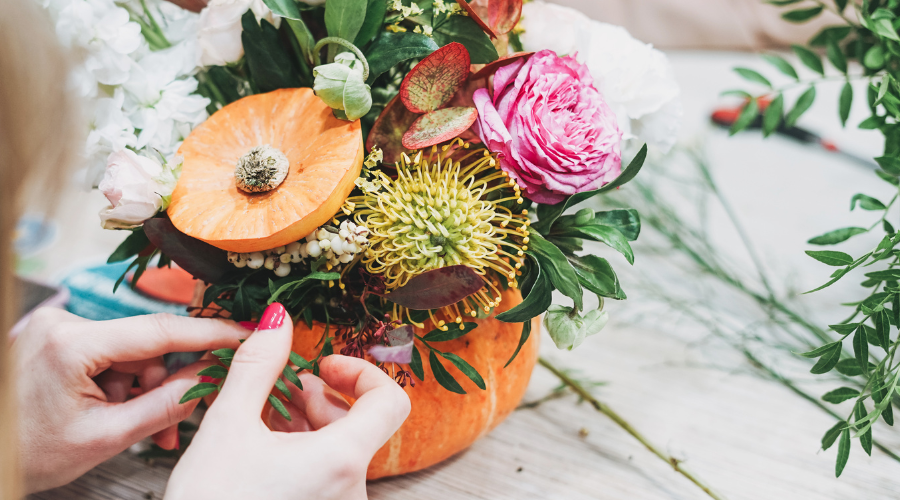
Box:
346 140 529 322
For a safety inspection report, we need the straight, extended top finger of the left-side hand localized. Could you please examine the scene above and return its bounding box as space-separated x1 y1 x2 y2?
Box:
72 314 250 366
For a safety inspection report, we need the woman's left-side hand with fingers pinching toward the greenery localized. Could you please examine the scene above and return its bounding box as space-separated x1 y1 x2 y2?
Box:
13 309 250 491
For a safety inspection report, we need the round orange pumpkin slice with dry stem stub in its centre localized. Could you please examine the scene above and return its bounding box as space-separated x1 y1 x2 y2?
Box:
168 88 364 253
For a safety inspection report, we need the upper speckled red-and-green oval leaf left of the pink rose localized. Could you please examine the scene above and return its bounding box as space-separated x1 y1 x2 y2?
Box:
400 42 471 113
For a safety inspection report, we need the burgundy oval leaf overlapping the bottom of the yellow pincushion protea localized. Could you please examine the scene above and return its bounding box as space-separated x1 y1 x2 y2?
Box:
384 266 484 310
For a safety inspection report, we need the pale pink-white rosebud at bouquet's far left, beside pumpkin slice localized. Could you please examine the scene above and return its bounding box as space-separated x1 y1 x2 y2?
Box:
100 149 174 229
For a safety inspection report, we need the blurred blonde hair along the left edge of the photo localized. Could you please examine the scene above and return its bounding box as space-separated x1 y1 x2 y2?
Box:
0 0 84 499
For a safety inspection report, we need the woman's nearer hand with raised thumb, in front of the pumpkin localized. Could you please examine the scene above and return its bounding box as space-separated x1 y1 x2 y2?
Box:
166 303 410 500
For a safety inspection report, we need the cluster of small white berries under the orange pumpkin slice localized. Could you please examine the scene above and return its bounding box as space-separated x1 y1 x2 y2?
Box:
228 220 369 278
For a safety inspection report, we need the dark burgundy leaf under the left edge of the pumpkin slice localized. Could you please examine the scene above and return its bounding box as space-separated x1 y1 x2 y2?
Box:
144 217 234 283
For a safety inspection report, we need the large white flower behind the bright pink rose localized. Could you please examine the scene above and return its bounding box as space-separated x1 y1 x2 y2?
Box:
521 0 682 152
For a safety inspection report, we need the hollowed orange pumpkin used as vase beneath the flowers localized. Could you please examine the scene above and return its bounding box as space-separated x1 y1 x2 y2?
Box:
284 289 540 479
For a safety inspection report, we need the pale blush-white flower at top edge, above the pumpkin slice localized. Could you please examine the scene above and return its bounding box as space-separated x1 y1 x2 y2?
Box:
198 0 280 66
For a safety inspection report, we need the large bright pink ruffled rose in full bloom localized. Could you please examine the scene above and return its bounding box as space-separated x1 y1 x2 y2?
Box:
474 50 622 204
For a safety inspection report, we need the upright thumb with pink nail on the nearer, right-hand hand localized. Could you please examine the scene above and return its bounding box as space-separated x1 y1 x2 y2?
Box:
210 302 293 420
